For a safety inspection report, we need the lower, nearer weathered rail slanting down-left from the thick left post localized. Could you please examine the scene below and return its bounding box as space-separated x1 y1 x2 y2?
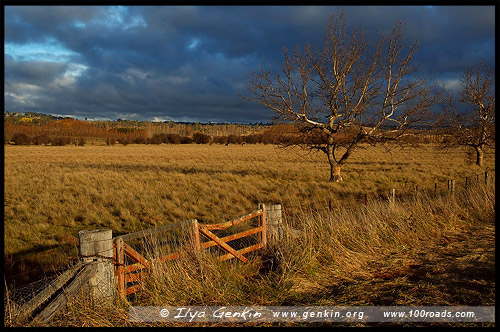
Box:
35 262 98 322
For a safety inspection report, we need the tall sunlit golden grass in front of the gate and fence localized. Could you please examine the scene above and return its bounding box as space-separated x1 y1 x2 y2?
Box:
128 179 495 312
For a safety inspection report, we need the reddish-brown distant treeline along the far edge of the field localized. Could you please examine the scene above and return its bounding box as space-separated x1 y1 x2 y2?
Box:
4 119 446 146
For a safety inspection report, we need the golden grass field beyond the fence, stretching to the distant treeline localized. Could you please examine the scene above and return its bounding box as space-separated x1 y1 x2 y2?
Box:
4 141 495 255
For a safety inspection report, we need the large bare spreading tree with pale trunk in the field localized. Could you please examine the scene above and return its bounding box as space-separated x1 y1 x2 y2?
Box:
244 13 439 182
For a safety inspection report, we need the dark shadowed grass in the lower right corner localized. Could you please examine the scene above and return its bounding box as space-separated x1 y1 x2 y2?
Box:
294 225 495 306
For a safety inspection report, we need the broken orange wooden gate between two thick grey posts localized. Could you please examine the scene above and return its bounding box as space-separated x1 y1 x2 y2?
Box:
113 204 267 298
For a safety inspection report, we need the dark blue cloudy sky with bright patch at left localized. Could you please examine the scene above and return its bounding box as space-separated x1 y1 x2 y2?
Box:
4 6 495 123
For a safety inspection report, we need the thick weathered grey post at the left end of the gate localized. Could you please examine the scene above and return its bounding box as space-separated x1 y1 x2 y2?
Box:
78 229 116 300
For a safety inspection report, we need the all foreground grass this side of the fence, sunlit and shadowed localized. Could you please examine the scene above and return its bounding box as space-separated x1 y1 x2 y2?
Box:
6 179 495 326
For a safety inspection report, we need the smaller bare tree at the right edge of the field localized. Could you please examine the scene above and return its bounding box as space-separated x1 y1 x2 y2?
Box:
445 62 495 166
